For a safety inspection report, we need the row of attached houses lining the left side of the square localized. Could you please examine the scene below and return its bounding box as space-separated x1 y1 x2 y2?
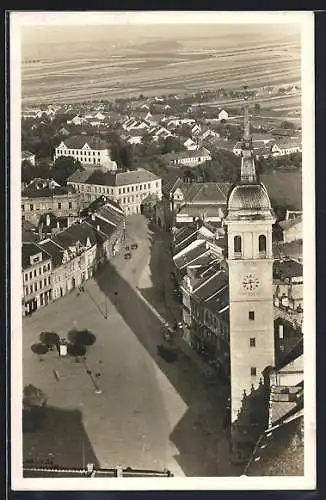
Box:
22 200 125 315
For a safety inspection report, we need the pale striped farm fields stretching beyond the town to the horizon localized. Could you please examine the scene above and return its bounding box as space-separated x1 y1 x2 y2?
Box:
22 33 301 105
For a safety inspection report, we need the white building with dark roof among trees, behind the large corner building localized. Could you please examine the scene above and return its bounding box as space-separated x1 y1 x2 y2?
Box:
55 135 117 170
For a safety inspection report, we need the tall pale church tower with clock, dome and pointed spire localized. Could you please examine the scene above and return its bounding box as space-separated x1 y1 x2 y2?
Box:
224 90 275 424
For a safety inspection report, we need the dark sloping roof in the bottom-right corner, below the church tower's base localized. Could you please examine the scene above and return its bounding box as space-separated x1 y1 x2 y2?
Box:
245 416 304 476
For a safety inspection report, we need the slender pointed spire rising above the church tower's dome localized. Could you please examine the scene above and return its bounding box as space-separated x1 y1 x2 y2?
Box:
241 85 257 184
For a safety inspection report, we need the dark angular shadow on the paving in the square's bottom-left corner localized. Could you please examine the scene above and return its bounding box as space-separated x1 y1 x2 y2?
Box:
23 406 99 477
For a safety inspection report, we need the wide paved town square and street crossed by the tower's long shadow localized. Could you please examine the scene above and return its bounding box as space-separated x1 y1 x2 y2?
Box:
23 216 238 476
